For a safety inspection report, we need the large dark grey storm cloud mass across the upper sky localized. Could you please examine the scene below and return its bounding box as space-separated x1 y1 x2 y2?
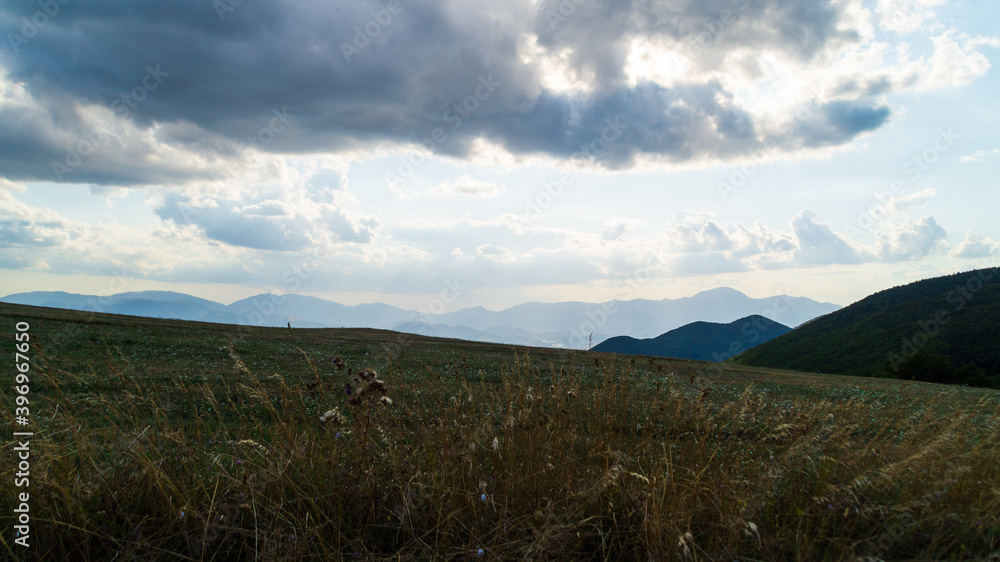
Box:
0 0 888 184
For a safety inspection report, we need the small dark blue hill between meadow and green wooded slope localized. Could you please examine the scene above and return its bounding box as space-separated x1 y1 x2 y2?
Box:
594 315 791 361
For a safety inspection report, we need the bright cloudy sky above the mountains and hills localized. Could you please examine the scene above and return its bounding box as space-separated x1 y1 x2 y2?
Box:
0 0 1000 310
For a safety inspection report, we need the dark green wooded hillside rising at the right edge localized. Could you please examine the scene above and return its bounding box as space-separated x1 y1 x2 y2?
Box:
735 268 1000 386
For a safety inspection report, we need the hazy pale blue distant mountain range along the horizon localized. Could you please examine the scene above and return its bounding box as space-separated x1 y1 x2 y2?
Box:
0 287 840 349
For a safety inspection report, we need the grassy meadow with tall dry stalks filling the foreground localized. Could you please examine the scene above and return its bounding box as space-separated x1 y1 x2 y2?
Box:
0 305 1000 561
